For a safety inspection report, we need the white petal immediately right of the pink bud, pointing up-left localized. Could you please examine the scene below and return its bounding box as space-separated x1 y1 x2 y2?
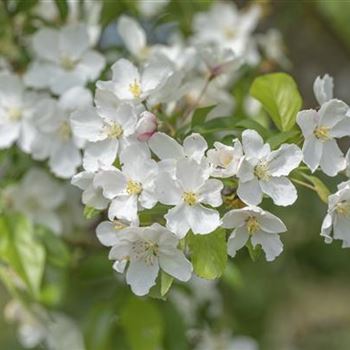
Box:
148 132 184 160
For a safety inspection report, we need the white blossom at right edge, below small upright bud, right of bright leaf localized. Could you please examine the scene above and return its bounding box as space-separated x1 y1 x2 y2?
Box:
297 99 350 176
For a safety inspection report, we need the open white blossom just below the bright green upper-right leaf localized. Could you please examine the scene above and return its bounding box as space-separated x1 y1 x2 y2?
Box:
237 130 303 206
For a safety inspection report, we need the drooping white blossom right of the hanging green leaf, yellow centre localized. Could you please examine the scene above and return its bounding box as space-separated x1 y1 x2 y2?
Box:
222 206 287 261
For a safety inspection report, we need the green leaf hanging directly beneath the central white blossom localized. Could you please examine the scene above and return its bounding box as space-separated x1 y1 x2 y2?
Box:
187 229 227 279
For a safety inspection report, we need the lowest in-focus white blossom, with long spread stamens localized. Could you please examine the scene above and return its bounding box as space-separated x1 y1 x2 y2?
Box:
109 223 192 296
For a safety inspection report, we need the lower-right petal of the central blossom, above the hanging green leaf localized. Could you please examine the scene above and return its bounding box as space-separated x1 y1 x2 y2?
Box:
185 204 221 234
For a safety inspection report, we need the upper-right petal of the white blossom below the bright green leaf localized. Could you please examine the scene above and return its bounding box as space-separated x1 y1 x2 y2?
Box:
268 144 303 176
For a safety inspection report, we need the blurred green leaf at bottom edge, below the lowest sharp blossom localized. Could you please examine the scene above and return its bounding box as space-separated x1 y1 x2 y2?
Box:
121 297 163 350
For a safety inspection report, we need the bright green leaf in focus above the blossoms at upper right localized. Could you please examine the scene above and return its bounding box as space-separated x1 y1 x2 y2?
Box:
250 73 302 131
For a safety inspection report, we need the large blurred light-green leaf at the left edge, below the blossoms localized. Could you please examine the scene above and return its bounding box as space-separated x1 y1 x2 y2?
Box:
0 214 46 297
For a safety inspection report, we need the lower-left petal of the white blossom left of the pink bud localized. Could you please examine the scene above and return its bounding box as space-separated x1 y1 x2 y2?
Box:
83 139 119 171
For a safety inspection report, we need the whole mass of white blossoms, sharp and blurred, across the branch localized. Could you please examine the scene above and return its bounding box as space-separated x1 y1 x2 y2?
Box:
0 1 350 302
